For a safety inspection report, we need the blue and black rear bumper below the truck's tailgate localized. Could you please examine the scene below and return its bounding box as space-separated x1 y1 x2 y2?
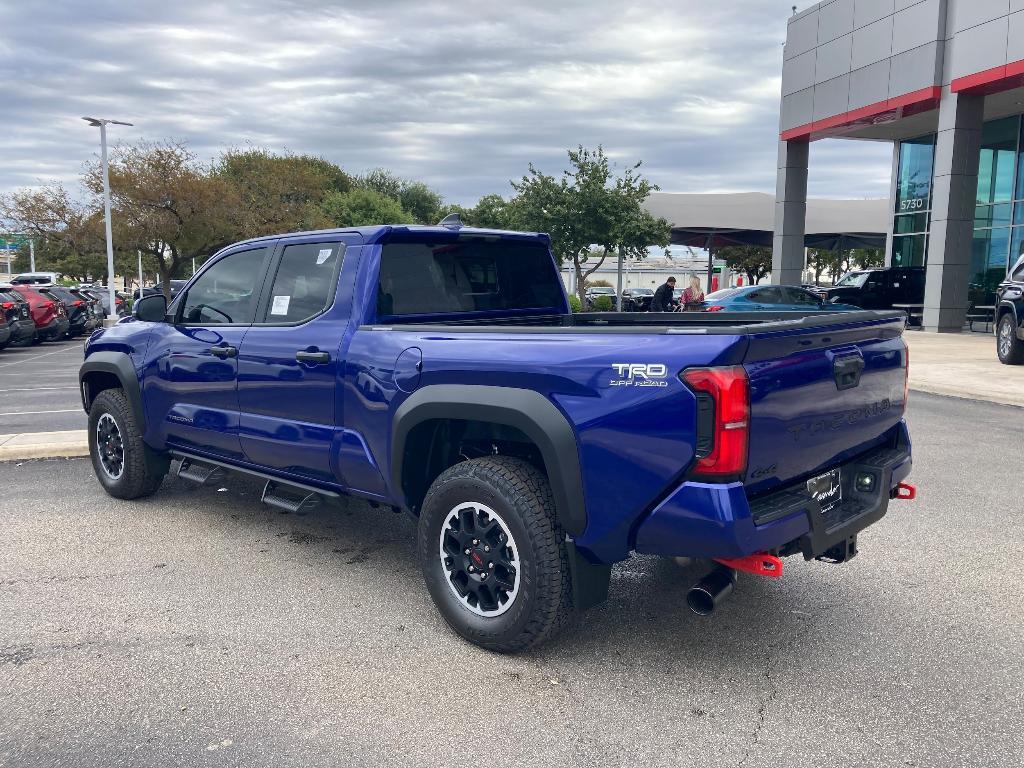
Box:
635 422 911 559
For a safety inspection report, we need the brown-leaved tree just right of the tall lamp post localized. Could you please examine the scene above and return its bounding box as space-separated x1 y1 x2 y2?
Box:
84 141 242 300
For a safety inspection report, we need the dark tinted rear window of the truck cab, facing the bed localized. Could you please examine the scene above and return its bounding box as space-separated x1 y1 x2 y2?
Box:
377 232 567 321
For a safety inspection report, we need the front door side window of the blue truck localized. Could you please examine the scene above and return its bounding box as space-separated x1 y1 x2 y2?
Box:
178 248 267 326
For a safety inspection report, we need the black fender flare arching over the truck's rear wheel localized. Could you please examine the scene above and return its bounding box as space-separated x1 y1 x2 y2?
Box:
390 384 587 536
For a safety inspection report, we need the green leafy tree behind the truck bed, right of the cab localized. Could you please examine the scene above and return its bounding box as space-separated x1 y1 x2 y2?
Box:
508 145 670 302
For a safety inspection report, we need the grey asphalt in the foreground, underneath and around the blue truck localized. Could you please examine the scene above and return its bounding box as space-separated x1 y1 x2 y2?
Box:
0 393 1024 768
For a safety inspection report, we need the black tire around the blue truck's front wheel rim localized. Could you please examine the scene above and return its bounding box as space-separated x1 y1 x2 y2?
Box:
89 389 170 499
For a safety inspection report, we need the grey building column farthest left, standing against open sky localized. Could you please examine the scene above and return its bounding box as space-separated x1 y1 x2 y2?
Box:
771 139 810 286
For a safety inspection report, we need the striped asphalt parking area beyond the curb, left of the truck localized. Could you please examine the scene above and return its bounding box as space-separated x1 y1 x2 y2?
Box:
0 339 86 434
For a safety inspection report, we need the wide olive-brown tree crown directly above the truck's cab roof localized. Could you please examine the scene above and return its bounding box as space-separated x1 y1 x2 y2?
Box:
215 148 352 240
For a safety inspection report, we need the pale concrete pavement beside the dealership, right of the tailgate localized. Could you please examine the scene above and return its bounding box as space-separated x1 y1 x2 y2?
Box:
903 331 1024 408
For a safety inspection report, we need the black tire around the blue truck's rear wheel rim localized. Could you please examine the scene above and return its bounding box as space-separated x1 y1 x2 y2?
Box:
418 456 572 652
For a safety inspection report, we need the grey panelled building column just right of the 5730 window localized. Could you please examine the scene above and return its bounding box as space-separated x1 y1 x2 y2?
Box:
924 88 985 333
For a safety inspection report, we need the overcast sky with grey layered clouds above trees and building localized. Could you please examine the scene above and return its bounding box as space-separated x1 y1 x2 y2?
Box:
0 0 891 204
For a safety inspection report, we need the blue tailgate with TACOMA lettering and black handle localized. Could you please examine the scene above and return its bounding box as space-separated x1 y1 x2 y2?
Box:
743 313 906 495
